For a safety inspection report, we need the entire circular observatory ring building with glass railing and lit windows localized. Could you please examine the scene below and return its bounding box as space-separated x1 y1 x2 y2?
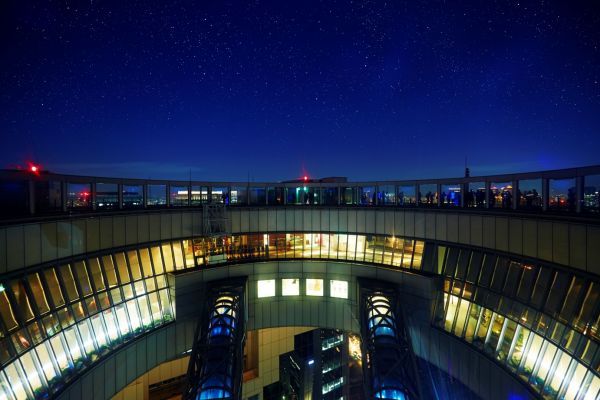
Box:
0 166 600 400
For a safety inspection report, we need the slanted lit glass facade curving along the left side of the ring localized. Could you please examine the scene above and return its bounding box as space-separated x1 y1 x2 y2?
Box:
0 244 174 399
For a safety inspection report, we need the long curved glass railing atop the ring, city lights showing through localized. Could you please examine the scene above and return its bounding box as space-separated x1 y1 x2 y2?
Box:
0 166 600 218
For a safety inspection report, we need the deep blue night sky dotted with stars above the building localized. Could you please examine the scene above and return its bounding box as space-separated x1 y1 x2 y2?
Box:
0 0 600 181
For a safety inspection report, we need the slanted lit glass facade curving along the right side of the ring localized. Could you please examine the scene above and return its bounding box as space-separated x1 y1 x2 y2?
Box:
432 241 600 399
